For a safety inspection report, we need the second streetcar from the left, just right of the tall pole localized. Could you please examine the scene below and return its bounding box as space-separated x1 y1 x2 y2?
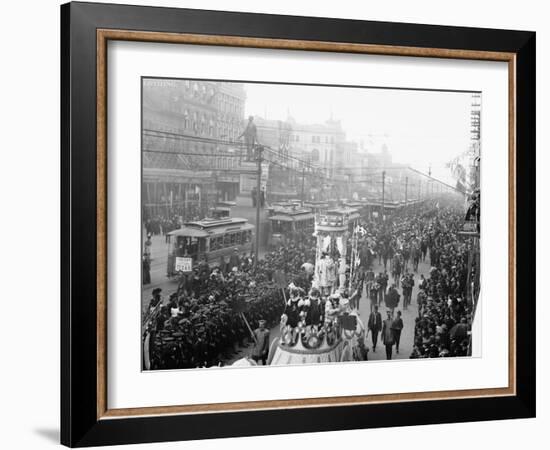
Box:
268 204 315 247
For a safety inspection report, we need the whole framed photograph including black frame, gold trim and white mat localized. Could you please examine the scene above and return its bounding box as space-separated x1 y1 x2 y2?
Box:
61 3 536 447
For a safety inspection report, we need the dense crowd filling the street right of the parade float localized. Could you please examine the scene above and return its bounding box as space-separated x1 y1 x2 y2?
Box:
360 205 479 359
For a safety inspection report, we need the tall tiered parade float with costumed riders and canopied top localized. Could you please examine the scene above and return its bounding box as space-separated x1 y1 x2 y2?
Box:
268 211 367 366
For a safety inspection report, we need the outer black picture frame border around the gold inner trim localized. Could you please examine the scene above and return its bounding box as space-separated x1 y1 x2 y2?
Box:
60 3 536 447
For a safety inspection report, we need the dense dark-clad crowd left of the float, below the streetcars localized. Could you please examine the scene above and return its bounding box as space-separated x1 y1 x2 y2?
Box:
145 243 312 369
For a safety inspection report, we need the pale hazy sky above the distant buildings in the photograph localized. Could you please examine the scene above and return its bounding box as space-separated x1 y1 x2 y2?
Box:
245 83 471 181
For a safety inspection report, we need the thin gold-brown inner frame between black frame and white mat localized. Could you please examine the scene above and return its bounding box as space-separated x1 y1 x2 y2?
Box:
96 29 516 420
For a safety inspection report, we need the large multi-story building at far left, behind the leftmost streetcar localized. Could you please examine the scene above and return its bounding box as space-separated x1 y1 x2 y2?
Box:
142 79 246 221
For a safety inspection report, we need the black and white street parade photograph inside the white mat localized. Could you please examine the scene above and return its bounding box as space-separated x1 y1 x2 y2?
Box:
141 77 481 370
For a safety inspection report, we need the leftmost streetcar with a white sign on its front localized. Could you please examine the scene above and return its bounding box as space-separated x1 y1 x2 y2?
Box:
166 217 254 278
